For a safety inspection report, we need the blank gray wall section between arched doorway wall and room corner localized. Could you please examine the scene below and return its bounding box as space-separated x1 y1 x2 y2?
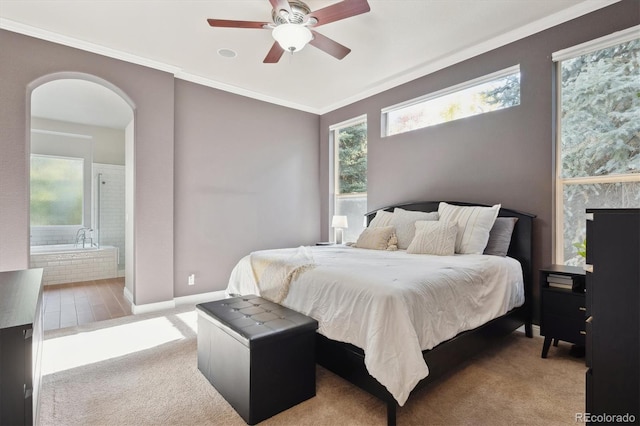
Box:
174 80 320 296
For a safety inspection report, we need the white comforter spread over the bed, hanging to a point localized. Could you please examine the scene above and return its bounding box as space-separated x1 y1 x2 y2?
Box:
227 246 524 405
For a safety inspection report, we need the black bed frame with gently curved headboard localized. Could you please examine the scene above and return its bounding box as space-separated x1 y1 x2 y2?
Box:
316 201 535 425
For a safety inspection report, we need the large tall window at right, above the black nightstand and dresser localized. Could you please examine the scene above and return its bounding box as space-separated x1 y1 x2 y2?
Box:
554 30 640 266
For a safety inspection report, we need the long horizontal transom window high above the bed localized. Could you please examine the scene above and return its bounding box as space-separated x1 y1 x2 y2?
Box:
382 65 520 136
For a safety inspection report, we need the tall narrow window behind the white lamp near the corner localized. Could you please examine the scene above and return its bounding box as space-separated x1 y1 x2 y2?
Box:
329 116 367 242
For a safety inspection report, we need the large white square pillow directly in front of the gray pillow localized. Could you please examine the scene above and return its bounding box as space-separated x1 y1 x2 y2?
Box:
438 202 500 254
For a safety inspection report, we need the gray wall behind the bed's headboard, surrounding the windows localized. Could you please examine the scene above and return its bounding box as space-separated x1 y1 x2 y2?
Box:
320 0 640 320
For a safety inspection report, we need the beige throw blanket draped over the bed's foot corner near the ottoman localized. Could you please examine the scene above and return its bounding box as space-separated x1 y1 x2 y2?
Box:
250 246 315 303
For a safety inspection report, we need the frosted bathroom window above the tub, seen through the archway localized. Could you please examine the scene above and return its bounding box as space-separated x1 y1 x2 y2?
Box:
31 154 84 226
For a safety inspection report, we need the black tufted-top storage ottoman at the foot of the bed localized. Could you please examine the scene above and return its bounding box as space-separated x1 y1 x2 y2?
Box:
196 295 318 424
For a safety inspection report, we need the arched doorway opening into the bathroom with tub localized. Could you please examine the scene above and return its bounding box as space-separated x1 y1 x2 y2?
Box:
27 73 135 326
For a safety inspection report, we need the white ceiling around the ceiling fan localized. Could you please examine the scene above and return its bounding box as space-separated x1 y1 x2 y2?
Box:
0 0 618 118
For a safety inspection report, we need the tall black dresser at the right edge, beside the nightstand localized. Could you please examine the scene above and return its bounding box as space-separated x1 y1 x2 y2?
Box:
586 209 640 424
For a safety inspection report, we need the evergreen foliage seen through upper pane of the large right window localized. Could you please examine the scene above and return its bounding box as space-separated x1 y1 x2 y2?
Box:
562 40 640 177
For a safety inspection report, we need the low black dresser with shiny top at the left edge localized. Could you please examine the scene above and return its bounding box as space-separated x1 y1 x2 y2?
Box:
0 268 43 425
